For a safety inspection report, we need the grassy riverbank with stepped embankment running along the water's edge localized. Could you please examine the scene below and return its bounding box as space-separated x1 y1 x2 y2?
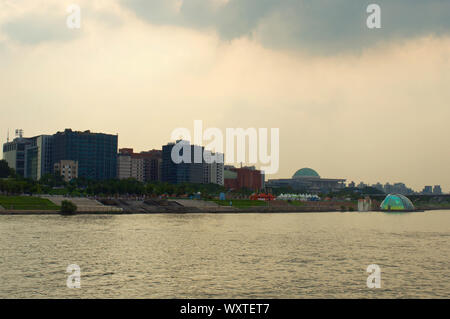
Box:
0 195 450 215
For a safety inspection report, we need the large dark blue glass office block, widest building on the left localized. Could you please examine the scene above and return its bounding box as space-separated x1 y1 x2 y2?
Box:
52 129 118 180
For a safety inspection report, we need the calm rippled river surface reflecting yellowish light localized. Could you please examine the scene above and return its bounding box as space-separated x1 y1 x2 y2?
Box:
0 211 450 298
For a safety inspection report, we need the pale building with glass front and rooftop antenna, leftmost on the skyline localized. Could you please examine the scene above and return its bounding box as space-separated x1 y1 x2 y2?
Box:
3 131 53 180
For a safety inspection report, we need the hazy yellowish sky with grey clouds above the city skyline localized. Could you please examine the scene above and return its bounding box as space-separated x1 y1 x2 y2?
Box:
0 0 450 192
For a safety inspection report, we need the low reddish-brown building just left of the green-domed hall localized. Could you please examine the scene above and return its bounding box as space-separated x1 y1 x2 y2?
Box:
224 166 263 191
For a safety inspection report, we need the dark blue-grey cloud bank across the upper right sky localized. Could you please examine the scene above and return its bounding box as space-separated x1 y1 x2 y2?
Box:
121 0 450 53
